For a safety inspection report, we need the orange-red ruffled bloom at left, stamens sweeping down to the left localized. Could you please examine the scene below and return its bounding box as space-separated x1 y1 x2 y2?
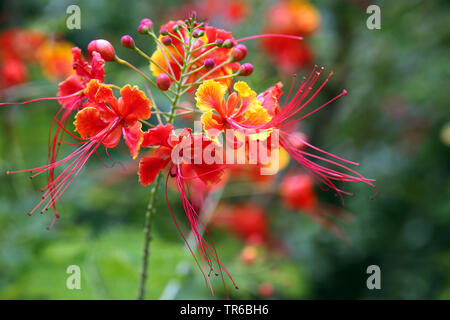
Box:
8 79 151 226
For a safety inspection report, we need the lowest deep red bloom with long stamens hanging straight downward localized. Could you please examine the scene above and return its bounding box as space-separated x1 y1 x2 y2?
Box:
138 124 236 292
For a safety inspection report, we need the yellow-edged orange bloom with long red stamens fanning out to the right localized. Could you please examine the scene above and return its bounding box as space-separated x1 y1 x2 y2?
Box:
196 67 376 201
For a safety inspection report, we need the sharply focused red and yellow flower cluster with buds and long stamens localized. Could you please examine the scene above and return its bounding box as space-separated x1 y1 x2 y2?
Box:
1 16 375 296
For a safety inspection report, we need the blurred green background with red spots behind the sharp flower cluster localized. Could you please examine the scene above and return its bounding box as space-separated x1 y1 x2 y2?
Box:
0 0 450 299
